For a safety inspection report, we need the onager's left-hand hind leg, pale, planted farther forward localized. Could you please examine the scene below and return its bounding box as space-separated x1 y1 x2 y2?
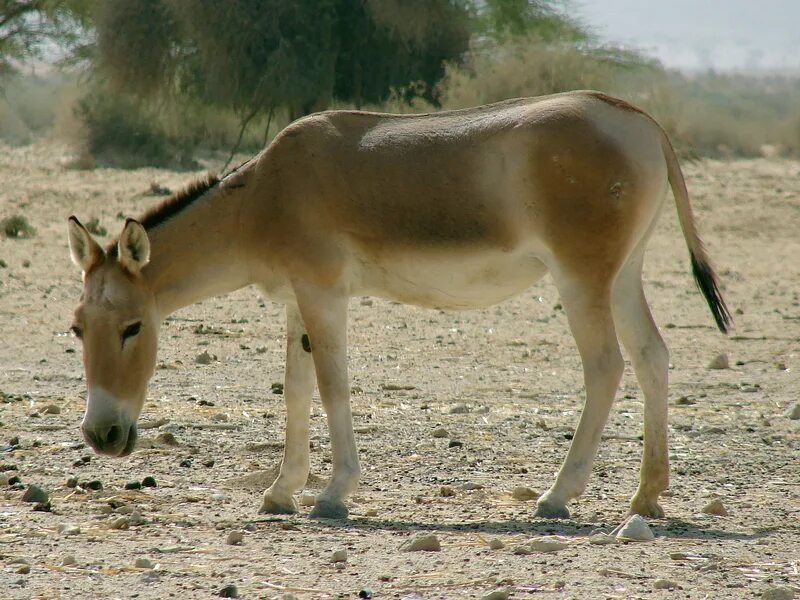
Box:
536 270 624 518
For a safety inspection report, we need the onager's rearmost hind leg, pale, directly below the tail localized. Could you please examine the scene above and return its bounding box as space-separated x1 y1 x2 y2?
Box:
612 250 669 517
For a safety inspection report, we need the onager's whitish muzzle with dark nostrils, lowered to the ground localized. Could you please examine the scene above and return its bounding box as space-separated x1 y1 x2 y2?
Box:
81 390 138 456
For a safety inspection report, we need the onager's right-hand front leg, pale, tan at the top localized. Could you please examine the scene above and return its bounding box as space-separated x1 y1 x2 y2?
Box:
293 281 361 519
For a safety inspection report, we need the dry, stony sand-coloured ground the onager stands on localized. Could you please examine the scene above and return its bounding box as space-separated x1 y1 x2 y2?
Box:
0 142 800 600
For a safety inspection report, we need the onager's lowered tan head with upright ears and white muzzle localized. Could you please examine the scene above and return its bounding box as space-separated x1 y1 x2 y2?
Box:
69 216 160 456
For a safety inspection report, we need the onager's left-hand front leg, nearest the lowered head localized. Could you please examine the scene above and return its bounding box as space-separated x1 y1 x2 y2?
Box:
258 305 314 514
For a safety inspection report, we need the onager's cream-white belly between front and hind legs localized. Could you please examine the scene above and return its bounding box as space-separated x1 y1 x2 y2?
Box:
353 252 547 310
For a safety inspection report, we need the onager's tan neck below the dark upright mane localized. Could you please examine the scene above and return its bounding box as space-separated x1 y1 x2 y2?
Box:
143 178 251 316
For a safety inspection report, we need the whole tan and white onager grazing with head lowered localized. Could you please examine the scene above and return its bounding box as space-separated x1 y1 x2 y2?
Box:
69 91 730 518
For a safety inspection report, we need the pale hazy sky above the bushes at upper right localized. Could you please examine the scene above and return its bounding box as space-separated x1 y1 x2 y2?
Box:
567 0 800 72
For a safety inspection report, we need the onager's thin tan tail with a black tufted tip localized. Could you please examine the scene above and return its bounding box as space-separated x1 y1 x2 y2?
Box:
662 130 733 333
